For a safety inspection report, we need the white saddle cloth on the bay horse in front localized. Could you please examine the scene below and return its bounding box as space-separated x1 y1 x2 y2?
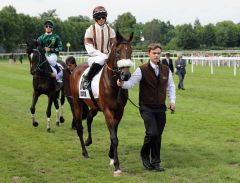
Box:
78 67 103 99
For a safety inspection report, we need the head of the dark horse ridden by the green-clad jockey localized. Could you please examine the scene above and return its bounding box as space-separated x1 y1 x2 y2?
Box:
26 39 42 75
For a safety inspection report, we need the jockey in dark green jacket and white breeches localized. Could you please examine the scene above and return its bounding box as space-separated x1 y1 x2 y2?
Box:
38 20 63 82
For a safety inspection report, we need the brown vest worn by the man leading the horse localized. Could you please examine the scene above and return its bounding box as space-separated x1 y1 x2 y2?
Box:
139 62 169 106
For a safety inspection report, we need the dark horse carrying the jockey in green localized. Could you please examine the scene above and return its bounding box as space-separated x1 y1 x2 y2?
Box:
27 39 66 132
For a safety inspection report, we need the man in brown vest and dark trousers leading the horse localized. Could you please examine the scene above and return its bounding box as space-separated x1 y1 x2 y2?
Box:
117 43 176 172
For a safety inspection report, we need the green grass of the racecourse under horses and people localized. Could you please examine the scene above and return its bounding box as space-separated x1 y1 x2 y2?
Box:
0 61 240 183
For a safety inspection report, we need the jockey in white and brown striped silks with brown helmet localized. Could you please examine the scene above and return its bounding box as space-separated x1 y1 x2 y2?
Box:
84 6 116 89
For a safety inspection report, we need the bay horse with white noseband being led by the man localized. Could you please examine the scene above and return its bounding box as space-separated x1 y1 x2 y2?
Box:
70 31 133 176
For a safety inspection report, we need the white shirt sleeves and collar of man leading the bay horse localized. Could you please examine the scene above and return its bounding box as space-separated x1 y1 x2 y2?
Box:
122 61 176 103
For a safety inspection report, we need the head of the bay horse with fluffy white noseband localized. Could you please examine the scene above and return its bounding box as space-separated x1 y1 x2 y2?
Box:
107 31 133 81
